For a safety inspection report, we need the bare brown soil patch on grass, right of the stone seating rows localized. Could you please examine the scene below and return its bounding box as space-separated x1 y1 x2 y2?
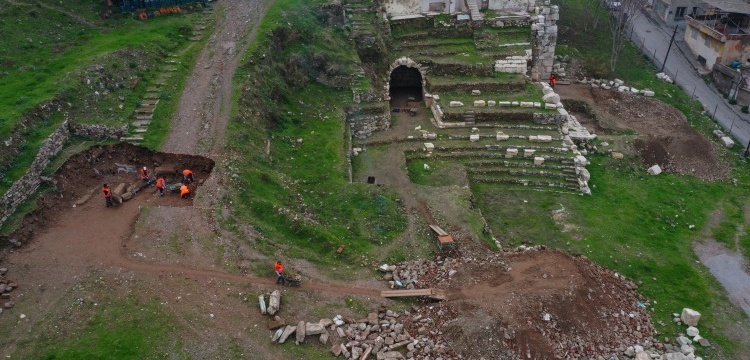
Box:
556 84 729 180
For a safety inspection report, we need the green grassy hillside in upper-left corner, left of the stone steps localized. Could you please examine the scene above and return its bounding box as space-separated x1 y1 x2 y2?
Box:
0 0 200 193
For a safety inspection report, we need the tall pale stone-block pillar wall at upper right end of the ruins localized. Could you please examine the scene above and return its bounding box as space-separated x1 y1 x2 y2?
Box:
530 0 560 81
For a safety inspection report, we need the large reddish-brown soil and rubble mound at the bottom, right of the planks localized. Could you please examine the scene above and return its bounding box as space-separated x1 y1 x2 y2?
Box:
396 248 655 359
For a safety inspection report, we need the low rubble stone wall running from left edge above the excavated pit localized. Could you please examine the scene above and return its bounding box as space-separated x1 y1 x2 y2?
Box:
0 120 128 226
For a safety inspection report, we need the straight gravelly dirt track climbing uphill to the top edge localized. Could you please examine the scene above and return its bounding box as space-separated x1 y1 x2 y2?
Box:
162 0 268 157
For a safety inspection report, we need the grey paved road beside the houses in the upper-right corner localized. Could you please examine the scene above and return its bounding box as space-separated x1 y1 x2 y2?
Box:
631 10 750 147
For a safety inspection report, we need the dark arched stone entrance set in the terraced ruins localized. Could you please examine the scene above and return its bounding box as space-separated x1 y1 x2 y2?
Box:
388 57 426 108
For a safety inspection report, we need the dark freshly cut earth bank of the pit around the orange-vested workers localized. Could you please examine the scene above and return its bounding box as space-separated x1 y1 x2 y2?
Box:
0 144 214 248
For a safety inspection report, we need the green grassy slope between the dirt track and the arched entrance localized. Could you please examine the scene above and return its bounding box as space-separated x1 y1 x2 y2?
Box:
226 0 405 270
